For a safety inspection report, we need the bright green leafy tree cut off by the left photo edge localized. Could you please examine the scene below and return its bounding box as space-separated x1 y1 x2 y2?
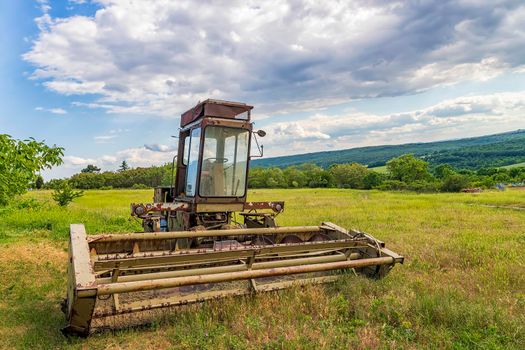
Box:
0 134 64 205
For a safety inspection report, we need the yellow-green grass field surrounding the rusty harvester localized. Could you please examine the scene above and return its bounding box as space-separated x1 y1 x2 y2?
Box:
0 189 525 349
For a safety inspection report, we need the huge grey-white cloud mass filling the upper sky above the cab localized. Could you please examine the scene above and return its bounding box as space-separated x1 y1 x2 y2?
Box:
23 0 525 117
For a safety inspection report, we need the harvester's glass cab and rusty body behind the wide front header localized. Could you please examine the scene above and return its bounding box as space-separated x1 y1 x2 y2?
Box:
131 100 284 235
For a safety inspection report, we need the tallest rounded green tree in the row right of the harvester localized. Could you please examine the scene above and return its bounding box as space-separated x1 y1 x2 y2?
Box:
386 154 431 184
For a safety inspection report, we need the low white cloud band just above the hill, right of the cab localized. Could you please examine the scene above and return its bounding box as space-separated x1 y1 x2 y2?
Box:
264 91 525 155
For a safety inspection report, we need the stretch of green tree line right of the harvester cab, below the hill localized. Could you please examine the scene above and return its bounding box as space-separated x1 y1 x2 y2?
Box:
248 154 525 192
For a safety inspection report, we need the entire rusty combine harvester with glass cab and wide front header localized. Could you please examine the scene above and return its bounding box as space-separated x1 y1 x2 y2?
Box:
63 100 403 335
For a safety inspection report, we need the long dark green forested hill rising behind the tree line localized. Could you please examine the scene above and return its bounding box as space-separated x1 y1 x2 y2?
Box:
252 130 525 169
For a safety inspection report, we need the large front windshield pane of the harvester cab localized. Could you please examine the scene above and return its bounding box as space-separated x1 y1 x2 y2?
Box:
199 126 249 197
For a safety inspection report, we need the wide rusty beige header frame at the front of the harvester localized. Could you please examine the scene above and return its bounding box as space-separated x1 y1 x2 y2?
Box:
64 223 403 335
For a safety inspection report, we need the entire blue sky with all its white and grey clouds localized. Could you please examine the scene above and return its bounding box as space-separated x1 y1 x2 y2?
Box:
0 0 525 179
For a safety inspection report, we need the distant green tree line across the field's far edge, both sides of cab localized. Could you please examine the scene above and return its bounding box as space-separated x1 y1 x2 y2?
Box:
44 154 525 192
